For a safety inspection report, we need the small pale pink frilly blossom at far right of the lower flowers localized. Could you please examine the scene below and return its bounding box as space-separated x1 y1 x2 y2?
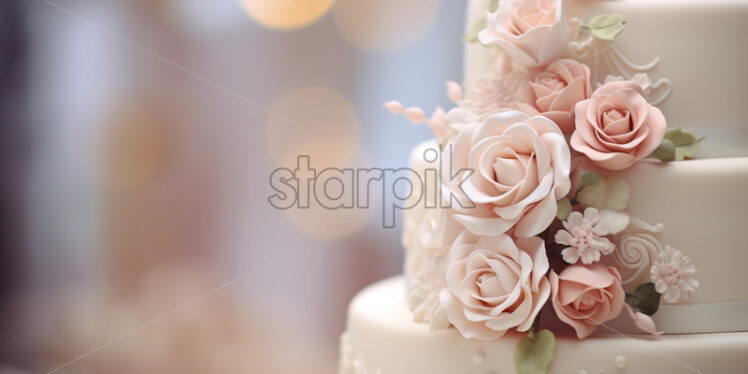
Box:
650 246 699 303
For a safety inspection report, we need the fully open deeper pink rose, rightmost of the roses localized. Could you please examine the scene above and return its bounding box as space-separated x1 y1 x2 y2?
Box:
570 81 667 170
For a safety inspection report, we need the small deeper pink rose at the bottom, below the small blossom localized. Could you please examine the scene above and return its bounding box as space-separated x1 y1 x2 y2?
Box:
549 262 626 339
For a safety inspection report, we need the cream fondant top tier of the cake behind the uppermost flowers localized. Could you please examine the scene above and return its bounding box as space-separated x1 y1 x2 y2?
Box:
465 0 748 157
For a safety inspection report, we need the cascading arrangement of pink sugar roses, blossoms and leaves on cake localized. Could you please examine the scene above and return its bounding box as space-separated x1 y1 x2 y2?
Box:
385 0 703 373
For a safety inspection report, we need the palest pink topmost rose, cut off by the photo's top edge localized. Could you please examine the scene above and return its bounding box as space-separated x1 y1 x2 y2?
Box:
478 0 570 67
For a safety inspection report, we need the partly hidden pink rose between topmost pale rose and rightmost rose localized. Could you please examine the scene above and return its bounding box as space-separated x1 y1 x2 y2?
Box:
520 59 592 134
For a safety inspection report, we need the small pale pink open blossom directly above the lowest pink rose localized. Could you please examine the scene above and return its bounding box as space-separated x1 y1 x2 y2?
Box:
555 208 616 265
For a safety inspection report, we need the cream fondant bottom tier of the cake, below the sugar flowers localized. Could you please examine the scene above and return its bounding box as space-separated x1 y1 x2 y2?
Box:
339 277 748 374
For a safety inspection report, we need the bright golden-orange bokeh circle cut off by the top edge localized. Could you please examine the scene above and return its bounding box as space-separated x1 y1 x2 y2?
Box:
241 0 335 30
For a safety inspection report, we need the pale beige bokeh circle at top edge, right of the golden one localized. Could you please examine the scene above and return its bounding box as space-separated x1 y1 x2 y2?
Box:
333 0 439 53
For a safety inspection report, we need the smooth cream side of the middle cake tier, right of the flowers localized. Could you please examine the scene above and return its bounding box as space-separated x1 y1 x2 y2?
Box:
618 157 748 306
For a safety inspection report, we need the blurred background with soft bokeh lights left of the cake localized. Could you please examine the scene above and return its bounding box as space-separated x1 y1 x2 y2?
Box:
0 0 465 374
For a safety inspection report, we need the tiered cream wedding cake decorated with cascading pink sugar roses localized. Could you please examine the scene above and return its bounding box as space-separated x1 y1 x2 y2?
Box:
339 0 748 374
